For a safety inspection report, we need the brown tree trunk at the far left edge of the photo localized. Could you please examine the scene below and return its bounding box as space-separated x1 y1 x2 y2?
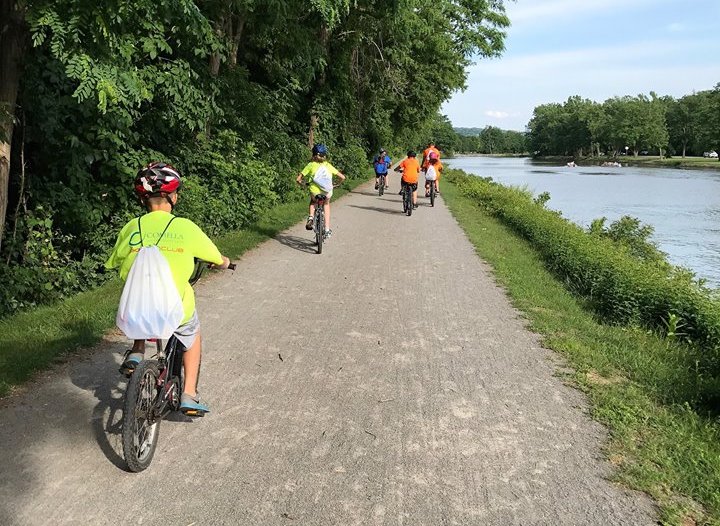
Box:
0 0 28 254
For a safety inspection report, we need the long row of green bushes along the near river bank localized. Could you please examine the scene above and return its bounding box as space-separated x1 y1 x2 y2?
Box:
448 171 720 377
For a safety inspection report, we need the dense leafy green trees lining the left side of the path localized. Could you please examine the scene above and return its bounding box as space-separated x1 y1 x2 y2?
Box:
0 0 509 316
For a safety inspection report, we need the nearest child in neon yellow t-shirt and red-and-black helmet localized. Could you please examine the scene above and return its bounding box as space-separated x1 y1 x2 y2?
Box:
105 162 230 414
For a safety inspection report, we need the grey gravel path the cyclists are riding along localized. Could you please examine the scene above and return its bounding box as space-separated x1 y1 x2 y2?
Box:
0 177 656 526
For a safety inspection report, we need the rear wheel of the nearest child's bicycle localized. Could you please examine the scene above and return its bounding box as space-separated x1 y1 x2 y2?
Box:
122 360 160 473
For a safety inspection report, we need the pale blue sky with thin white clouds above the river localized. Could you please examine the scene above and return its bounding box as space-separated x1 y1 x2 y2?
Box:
441 0 720 130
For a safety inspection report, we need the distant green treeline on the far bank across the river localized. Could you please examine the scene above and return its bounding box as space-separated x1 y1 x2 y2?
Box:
443 84 720 159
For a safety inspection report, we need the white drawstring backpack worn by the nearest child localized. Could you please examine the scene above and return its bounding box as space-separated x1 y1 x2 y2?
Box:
115 217 184 340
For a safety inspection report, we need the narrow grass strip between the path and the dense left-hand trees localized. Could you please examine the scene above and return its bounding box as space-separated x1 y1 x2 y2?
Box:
0 175 370 397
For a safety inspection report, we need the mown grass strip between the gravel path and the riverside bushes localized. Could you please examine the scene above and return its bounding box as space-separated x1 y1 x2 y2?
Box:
443 178 720 525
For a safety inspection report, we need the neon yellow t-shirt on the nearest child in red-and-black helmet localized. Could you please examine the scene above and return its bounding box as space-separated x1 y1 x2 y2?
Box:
105 210 223 323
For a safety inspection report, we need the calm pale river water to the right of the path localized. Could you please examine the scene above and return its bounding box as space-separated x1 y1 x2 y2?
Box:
444 157 720 287
